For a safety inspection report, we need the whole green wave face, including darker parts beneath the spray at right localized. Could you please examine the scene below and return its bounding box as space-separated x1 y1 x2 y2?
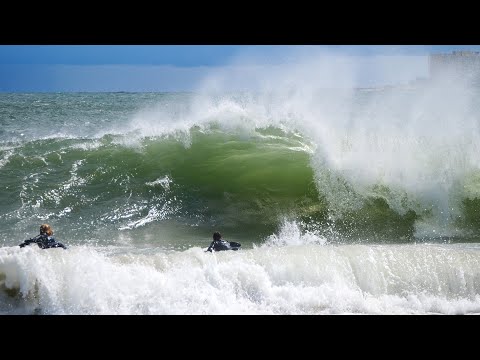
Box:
4 123 480 243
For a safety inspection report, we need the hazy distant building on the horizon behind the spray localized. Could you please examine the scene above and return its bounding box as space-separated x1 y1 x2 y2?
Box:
429 51 480 82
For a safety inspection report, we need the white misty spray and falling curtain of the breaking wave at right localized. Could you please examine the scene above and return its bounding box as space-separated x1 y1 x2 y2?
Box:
190 53 479 240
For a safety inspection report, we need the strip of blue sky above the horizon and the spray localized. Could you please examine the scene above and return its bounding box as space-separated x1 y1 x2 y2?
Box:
0 45 480 92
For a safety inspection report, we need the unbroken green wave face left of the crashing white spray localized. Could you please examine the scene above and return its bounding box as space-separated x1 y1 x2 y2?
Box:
0 128 326 245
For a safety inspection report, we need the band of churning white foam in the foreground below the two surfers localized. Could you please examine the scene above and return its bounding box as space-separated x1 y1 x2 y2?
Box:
0 243 480 314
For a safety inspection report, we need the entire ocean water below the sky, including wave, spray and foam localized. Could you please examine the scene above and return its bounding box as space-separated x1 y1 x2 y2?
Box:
0 85 480 315
